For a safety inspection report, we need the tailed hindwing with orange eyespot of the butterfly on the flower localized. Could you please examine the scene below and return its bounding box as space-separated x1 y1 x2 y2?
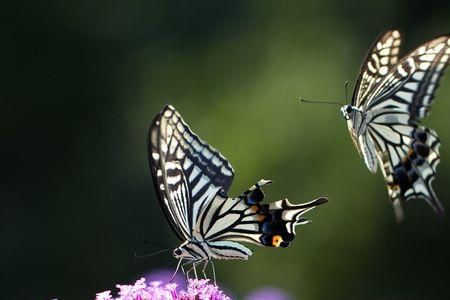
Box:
195 180 328 258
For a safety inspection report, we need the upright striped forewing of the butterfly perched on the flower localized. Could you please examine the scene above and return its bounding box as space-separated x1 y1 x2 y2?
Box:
148 105 234 241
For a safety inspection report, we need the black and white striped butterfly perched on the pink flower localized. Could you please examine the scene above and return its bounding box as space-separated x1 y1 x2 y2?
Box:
148 105 328 277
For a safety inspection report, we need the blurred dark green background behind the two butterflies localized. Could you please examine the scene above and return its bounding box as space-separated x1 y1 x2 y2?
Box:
0 0 450 300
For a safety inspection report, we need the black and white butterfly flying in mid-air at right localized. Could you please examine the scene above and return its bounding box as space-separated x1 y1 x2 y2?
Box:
341 30 450 221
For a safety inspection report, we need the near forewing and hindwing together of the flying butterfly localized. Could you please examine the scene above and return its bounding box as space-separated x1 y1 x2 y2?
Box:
363 36 450 214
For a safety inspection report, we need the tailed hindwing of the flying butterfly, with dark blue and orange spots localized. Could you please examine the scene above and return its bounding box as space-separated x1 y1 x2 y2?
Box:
369 118 444 215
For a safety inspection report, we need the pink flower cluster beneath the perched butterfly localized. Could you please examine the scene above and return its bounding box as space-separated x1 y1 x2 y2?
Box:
95 278 231 300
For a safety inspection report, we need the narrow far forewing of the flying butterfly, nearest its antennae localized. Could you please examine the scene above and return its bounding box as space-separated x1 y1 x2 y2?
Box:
352 30 401 108
